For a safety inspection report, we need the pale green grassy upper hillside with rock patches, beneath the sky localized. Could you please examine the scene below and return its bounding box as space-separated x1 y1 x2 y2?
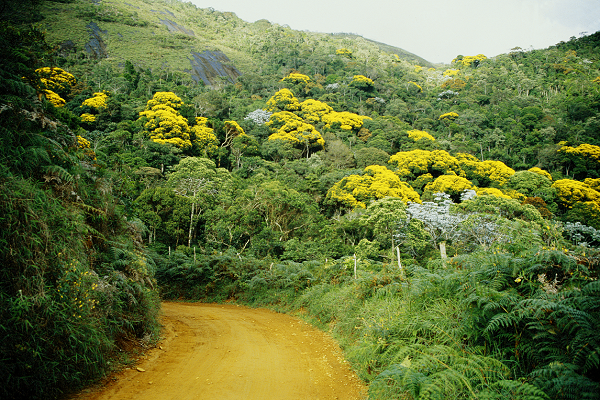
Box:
42 0 430 85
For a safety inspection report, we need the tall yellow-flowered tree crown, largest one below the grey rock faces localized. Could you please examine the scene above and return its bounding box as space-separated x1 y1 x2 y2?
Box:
139 92 192 149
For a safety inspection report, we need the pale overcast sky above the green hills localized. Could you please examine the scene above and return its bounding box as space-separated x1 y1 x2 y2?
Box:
191 0 600 63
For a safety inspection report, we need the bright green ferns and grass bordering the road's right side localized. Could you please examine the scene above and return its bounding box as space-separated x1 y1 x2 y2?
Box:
157 248 600 400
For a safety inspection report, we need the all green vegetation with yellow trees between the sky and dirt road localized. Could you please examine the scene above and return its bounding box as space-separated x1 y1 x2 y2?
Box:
0 0 600 400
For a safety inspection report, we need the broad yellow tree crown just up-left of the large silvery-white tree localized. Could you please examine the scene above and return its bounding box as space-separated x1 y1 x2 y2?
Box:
327 165 421 209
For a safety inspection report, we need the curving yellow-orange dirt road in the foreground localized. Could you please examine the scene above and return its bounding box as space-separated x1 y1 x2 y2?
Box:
77 303 366 400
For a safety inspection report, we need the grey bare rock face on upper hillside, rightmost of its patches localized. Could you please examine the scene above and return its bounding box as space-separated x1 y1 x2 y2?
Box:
186 50 242 86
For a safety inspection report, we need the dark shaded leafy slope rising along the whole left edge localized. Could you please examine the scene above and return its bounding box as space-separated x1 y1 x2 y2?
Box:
0 17 159 399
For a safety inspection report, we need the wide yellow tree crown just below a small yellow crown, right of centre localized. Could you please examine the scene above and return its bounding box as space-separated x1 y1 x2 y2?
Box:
389 150 465 179
